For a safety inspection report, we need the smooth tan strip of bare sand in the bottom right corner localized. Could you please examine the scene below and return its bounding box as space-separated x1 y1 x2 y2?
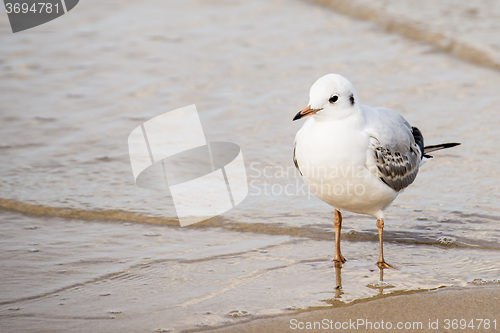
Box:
207 284 500 333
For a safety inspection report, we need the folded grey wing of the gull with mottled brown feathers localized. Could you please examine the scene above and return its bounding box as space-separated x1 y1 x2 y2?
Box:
366 109 423 192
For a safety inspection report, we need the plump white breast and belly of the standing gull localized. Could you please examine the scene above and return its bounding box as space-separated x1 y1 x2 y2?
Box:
295 117 397 218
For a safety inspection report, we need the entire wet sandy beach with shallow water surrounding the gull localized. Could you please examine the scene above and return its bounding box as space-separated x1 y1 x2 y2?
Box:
0 0 500 332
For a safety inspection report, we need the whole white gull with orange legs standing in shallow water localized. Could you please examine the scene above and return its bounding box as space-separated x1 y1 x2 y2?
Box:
293 74 460 269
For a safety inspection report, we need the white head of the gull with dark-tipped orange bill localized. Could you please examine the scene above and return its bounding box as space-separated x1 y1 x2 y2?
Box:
293 74 359 120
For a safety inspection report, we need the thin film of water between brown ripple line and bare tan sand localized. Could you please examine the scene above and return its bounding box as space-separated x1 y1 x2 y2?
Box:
0 211 499 332
